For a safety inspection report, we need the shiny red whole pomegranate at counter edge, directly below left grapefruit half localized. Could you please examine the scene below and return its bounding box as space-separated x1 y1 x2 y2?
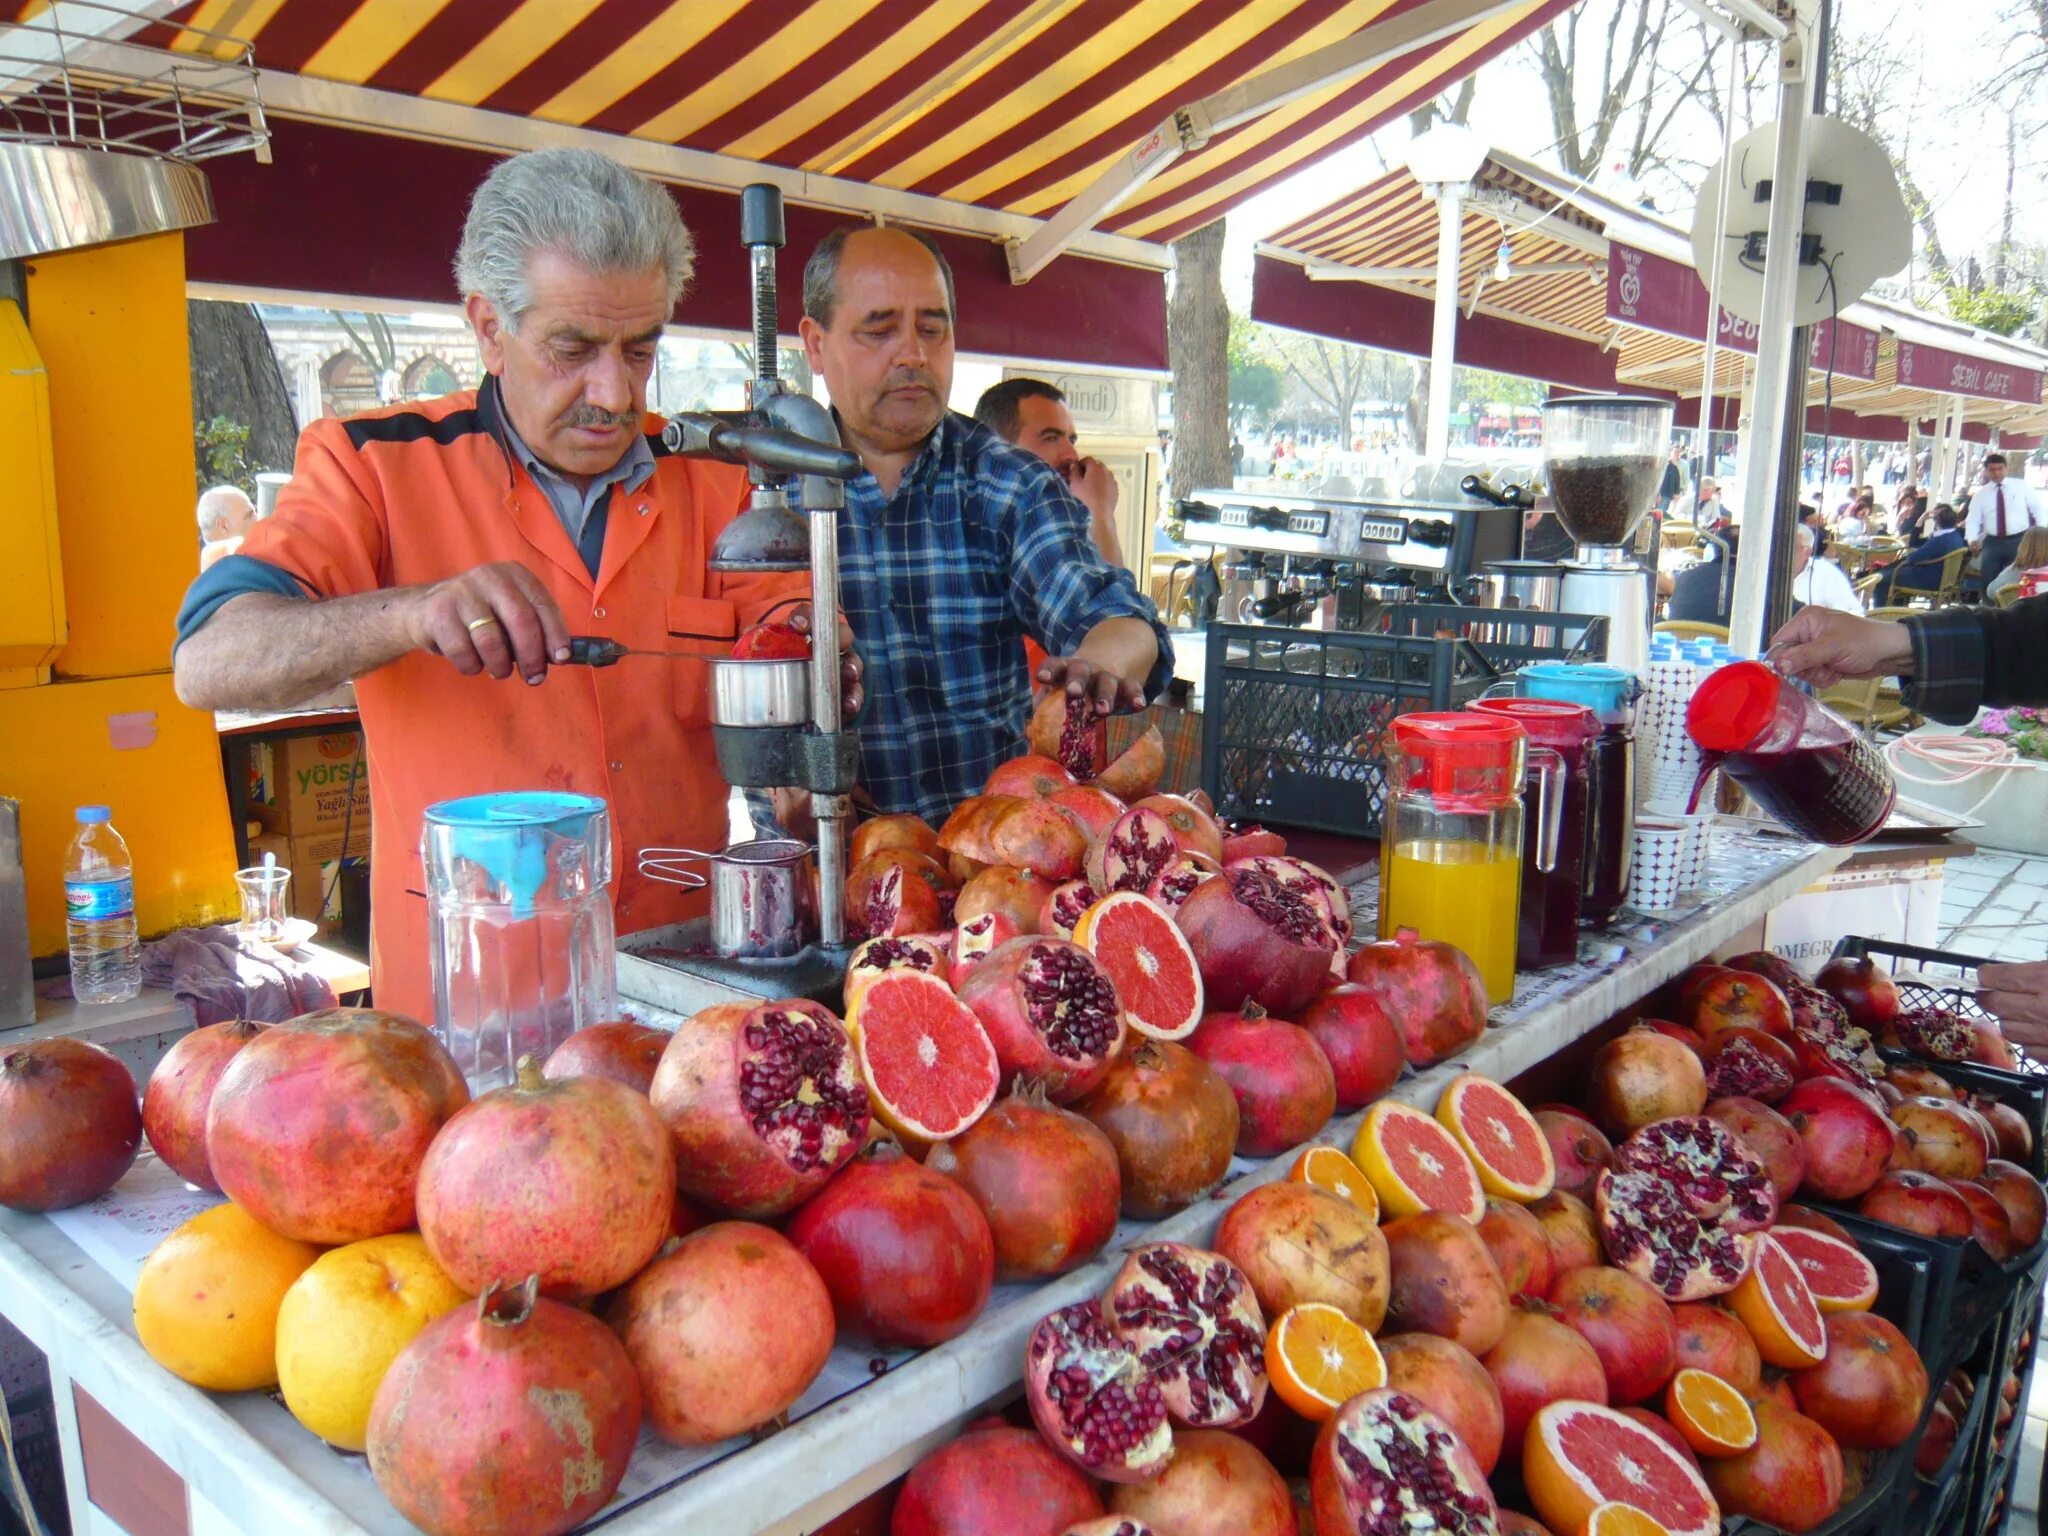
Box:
788 1145 995 1348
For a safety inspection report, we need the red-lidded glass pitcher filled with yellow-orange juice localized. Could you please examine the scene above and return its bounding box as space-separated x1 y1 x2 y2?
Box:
1380 713 1561 1001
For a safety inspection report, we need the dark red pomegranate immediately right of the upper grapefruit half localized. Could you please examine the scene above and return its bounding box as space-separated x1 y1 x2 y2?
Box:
1174 868 1335 1024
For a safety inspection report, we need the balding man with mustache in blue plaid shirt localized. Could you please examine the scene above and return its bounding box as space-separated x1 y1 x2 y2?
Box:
801 227 1174 825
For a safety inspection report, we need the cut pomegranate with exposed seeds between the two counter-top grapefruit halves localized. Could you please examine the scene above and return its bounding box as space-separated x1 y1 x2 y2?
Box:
961 938 1124 1104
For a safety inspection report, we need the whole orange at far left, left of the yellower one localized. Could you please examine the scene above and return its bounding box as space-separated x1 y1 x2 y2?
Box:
135 1202 319 1393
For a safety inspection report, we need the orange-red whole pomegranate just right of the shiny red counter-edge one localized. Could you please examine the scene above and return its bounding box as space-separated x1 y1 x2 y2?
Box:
924 1087 1122 1280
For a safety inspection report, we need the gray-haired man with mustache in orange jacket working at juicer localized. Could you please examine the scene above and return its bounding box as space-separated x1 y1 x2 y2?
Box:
174 150 858 1018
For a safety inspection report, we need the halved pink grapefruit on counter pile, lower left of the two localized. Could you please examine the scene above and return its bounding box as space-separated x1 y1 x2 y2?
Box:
848 969 1001 1141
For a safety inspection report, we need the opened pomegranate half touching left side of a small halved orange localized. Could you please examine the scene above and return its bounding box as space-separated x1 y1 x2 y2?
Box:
1102 1243 1266 1430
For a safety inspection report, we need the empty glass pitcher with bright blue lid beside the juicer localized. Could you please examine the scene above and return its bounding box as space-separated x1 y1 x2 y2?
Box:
420 793 618 1094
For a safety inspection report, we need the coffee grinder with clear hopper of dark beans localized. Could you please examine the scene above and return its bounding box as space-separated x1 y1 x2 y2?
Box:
1542 395 1671 672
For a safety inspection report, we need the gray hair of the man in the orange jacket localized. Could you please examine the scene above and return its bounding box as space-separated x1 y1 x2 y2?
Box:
455 150 696 328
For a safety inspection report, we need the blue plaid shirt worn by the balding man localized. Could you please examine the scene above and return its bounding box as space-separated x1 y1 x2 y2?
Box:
840 414 1174 827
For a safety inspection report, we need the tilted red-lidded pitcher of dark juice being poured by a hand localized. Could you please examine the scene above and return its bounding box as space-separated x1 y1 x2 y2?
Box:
1686 662 1898 848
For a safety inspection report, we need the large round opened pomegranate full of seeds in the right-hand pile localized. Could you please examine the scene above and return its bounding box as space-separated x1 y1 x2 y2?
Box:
1593 1114 1778 1300
